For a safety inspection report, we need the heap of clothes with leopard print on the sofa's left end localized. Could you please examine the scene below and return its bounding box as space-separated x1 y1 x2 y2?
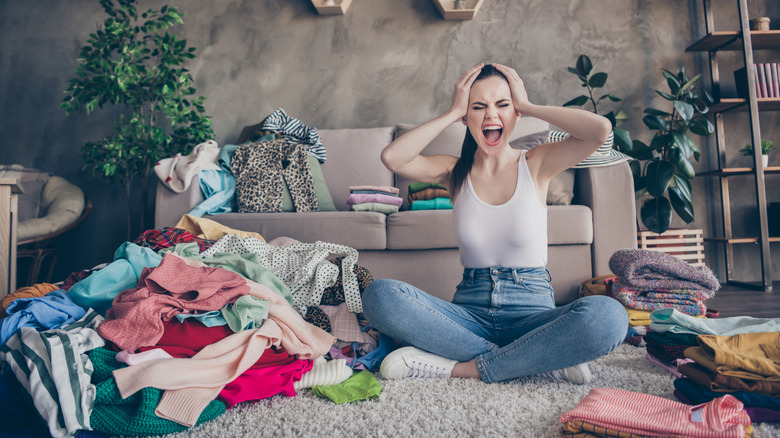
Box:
154 108 335 217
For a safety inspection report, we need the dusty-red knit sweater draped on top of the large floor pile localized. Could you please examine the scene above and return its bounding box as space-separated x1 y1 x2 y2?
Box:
97 254 249 350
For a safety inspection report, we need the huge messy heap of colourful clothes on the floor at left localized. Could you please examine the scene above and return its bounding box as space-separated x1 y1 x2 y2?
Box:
0 216 392 437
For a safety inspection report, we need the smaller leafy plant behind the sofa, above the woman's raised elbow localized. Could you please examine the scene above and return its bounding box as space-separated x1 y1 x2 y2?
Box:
563 55 631 148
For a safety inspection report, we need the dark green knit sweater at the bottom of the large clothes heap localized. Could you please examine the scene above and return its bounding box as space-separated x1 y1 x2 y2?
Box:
87 348 225 436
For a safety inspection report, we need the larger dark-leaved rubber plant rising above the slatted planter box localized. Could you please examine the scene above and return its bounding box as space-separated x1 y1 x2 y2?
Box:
621 67 714 234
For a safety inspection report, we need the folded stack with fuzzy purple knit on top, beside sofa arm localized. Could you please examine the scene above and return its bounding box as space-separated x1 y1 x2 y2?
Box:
609 249 720 323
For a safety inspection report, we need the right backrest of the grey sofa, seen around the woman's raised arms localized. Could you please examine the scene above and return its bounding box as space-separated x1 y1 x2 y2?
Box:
394 117 550 209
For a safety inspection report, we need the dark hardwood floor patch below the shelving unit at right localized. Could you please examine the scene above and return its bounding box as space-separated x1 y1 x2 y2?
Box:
704 282 780 318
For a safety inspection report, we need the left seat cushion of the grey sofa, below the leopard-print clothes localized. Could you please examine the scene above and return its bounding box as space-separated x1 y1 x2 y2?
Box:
204 211 387 250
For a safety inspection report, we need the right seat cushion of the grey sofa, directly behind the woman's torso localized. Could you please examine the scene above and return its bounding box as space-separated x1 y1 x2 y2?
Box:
387 205 593 249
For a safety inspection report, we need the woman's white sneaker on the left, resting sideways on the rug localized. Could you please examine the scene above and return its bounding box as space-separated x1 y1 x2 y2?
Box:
379 347 458 379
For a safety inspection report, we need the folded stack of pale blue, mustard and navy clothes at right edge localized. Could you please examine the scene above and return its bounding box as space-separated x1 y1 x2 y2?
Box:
646 309 780 422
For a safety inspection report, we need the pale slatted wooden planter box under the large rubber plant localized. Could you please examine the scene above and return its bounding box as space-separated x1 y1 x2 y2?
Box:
637 229 704 266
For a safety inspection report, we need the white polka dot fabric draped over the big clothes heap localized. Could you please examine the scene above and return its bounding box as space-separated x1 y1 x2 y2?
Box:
203 234 363 315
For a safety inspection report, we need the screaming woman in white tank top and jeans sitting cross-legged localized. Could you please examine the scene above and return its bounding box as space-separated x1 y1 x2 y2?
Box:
363 64 628 384
